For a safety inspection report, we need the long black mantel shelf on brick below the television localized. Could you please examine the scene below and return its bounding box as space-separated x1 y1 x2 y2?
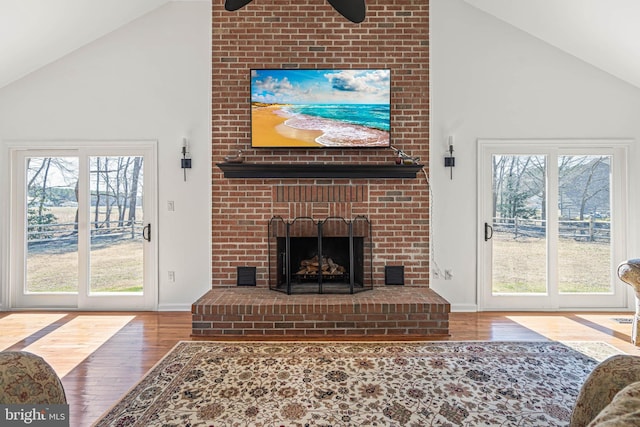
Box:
217 163 423 179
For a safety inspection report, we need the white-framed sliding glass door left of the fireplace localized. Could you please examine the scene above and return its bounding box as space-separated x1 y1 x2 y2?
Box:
11 146 157 309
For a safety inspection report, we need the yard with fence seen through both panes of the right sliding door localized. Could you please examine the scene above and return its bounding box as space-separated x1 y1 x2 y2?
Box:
492 155 611 293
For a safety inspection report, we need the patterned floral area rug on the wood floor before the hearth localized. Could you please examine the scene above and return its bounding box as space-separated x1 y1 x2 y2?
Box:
95 341 616 427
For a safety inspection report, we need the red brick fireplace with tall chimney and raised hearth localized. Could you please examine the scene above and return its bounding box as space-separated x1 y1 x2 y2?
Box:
193 0 449 336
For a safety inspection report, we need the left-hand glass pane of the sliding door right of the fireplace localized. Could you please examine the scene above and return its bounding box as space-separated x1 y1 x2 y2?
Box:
491 155 548 295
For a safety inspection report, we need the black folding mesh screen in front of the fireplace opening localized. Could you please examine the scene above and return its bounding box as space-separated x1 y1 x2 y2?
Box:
269 216 373 294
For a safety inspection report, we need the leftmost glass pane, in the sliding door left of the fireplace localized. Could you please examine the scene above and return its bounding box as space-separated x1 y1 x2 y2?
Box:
24 157 79 294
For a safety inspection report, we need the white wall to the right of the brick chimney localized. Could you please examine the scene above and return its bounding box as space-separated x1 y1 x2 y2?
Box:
430 0 640 311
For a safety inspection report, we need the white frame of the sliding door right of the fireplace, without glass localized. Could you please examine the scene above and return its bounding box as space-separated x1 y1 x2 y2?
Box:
477 139 633 311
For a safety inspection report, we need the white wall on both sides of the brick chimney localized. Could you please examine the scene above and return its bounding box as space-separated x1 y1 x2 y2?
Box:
0 0 640 310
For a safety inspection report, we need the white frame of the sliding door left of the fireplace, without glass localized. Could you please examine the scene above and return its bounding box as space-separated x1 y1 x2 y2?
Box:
2 140 158 310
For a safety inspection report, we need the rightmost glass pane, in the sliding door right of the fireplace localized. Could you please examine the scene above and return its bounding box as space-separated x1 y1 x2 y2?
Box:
558 155 613 294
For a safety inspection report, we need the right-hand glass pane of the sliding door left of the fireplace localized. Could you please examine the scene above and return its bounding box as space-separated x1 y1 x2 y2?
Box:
89 156 144 294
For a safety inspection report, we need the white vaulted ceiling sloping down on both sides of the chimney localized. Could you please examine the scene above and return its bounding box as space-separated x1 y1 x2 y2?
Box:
0 0 640 88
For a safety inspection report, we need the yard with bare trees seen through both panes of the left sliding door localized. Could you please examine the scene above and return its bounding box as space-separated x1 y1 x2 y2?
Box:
26 156 143 292
